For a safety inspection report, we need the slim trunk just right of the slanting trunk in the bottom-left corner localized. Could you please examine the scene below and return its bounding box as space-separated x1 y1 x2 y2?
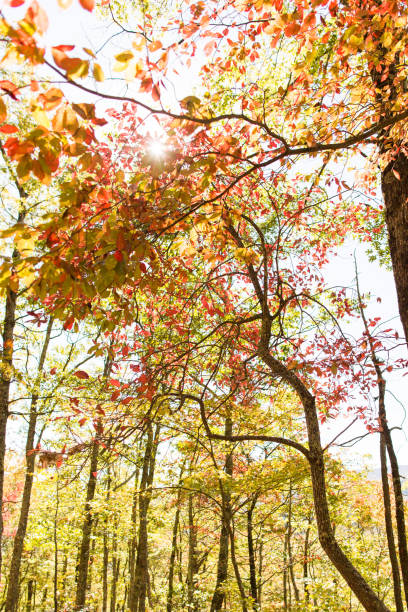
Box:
74 440 99 610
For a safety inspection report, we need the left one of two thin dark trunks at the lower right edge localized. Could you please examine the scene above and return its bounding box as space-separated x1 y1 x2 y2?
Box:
380 433 404 612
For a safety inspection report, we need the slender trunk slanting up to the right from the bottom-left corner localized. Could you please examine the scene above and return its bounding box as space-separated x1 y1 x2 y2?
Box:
5 318 53 612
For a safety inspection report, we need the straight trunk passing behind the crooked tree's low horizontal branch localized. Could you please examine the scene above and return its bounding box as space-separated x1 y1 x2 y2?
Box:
211 416 233 612
